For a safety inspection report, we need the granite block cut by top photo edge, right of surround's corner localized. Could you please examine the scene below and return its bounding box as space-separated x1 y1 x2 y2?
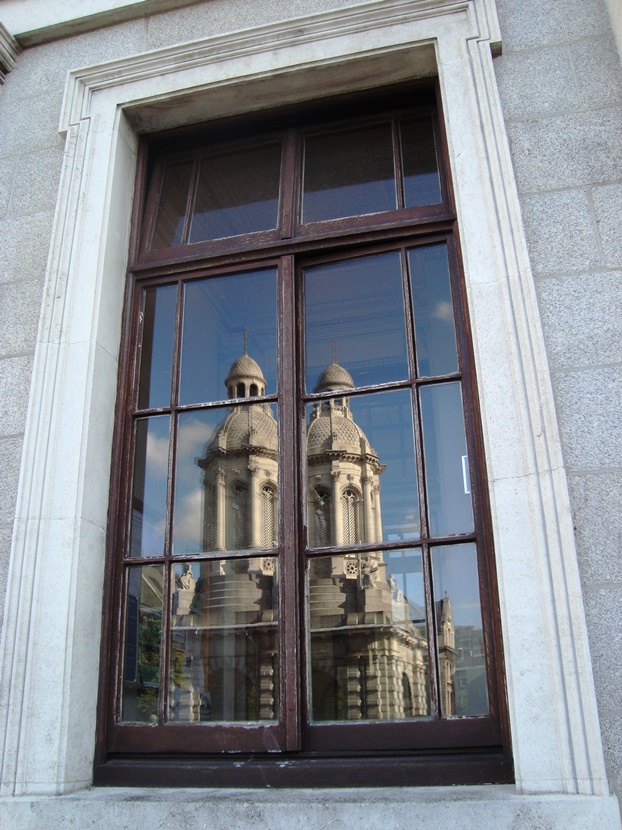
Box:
497 0 611 51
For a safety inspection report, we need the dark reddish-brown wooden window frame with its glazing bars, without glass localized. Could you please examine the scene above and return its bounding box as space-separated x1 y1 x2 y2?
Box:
94 85 513 787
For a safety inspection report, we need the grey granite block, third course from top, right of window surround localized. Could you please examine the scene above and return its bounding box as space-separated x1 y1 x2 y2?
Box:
508 108 622 193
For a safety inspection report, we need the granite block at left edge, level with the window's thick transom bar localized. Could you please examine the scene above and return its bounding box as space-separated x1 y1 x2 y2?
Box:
0 211 54 284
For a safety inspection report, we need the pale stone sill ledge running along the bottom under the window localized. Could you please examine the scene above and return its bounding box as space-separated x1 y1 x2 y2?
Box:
0 786 620 830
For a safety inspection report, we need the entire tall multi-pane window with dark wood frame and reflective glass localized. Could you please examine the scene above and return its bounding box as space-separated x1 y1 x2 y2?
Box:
96 90 511 785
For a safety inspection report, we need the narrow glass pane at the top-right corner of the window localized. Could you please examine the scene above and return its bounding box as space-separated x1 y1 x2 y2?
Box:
400 118 442 207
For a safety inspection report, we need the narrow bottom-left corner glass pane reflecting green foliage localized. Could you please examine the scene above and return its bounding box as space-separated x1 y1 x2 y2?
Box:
121 565 163 723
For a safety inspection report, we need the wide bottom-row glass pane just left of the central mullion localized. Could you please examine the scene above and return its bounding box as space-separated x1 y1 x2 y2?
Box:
169 556 279 723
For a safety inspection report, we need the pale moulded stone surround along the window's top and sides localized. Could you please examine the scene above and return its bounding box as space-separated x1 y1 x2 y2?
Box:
0 0 619 828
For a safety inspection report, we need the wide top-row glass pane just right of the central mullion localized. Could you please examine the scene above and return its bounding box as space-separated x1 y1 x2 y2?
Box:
302 124 397 222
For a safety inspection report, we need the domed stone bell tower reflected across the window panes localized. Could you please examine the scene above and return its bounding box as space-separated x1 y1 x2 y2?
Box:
169 353 456 722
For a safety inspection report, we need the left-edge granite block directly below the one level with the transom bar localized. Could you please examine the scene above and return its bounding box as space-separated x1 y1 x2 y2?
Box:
0 280 42 355
